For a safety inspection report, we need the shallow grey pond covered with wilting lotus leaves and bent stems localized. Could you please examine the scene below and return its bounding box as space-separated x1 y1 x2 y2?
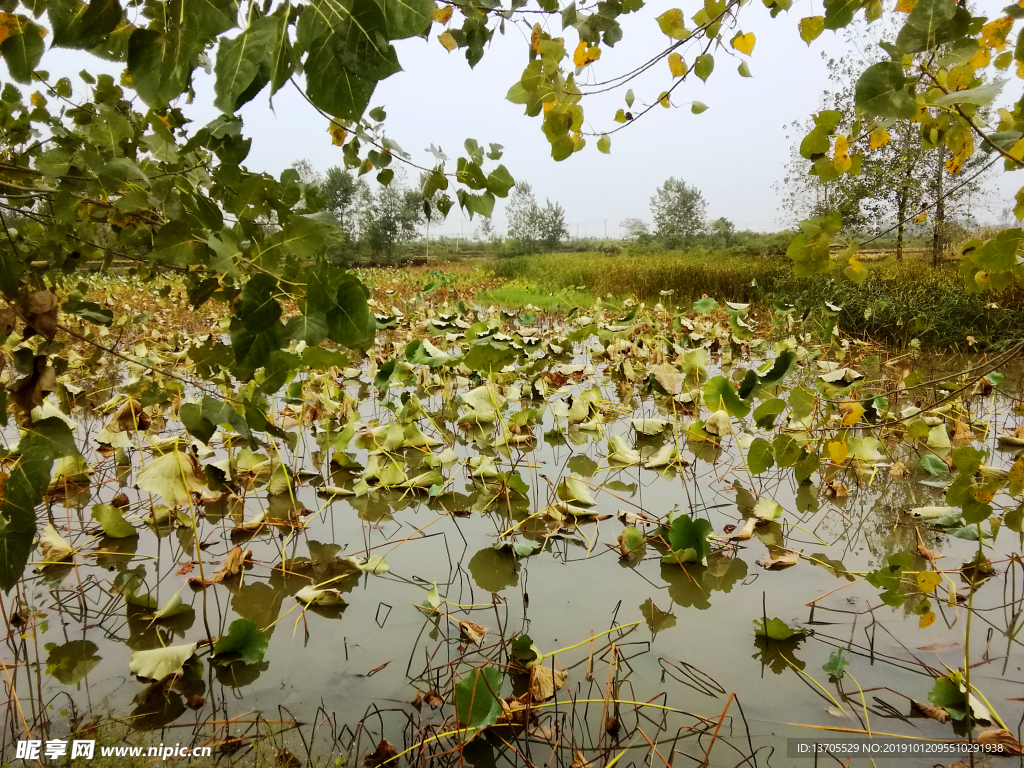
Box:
2 274 1024 768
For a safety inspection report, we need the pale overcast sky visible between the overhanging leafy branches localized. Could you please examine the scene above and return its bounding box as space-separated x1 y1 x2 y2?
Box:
43 0 1024 238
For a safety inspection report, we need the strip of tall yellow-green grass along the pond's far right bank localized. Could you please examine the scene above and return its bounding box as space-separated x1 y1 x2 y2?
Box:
492 251 1024 349
